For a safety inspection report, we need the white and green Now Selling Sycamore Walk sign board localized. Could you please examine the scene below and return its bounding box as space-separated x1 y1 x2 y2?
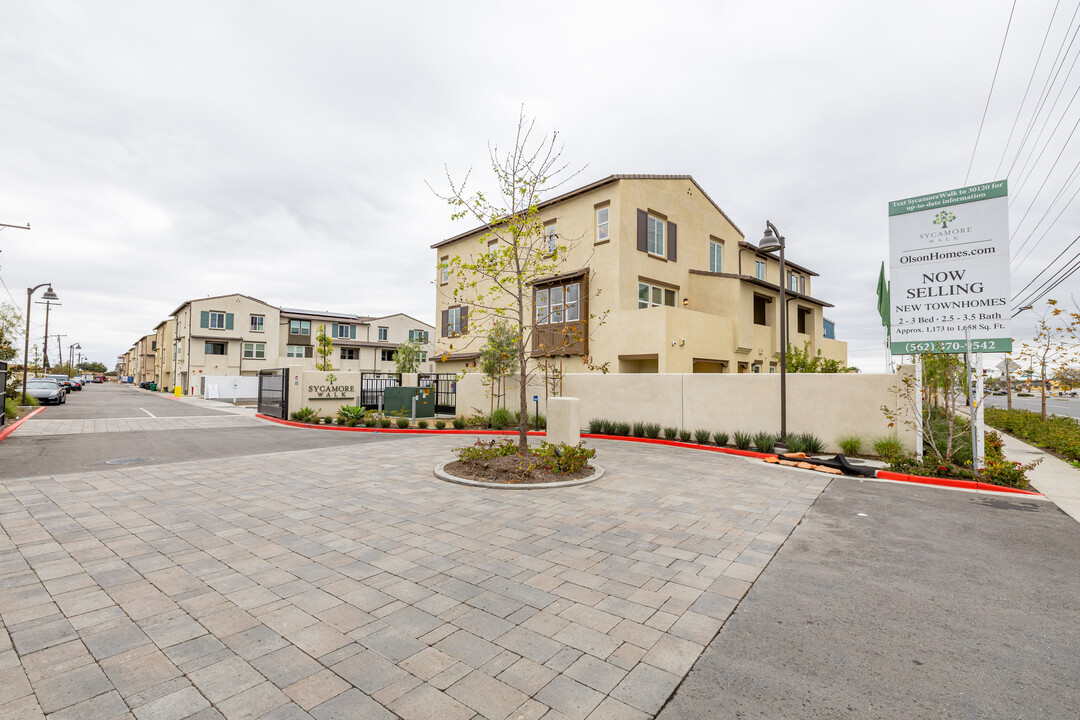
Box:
889 180 1012 355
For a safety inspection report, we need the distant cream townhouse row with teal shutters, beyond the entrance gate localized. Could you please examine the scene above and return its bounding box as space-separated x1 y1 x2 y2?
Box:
132 294 435 394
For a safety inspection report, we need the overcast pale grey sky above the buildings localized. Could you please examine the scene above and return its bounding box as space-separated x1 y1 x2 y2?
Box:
0 0 1080 371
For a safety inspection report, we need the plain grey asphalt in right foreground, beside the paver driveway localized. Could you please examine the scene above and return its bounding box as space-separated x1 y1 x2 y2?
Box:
659 478 1080 720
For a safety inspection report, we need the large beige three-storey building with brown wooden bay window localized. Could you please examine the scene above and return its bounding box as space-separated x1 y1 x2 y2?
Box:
432 175 847 372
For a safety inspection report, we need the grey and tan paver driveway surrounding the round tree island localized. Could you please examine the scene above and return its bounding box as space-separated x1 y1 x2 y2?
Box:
0 431 828 720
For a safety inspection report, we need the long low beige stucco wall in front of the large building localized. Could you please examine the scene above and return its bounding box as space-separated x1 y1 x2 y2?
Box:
457 366 915 450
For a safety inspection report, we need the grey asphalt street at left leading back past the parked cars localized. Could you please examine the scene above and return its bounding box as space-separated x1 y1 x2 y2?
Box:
0 384 403 478
